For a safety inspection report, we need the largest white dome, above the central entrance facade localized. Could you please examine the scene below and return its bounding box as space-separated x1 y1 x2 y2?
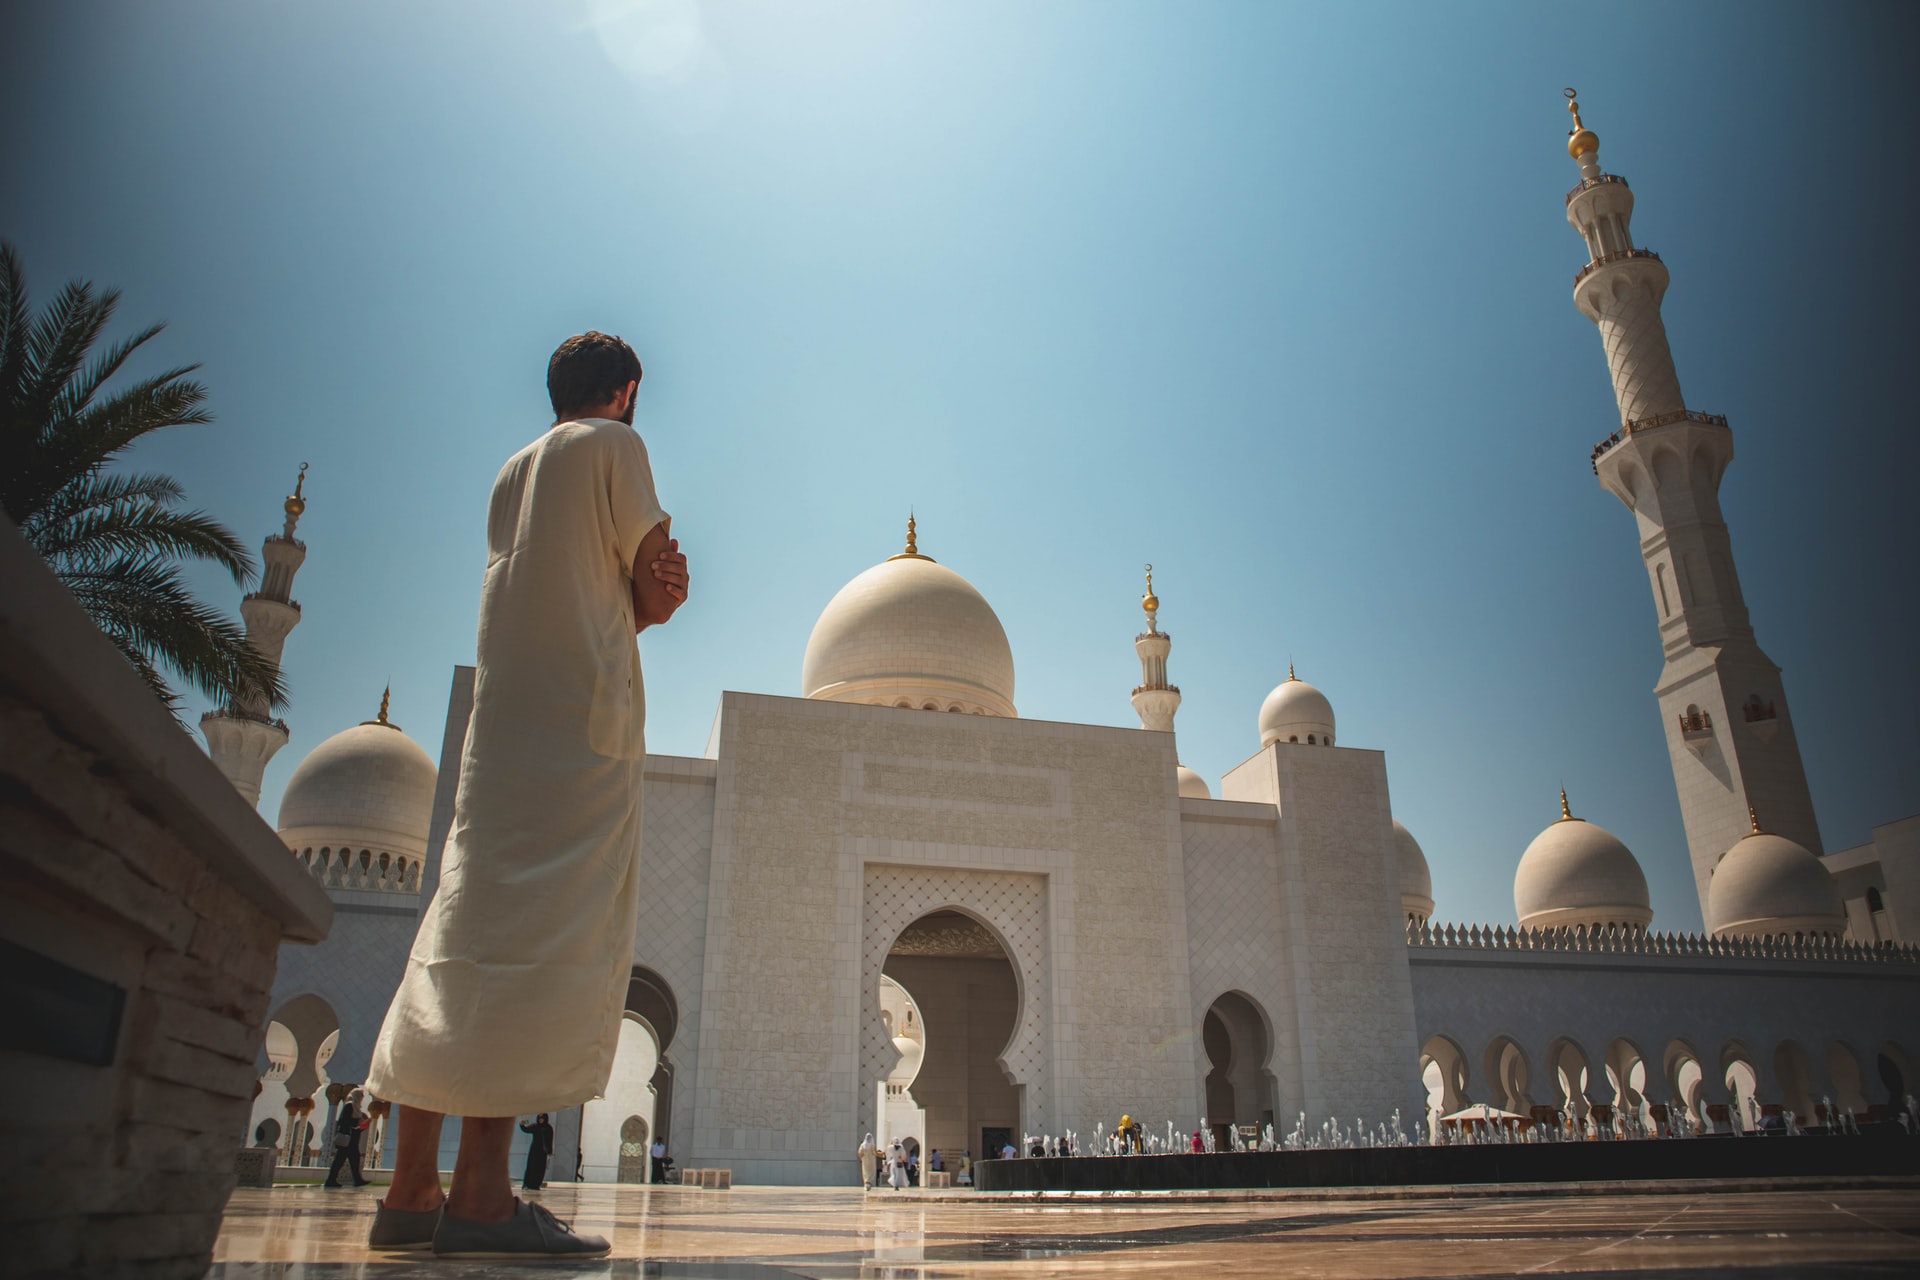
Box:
801 525 1016 716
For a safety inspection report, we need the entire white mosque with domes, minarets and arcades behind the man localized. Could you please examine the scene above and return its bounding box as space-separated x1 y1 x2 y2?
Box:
205 94 1920 1184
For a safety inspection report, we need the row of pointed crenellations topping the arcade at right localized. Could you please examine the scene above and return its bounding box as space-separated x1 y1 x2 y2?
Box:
1407 921 1920 965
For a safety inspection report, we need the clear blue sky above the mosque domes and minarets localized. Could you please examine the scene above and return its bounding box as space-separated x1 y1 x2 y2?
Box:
0 0 1920 929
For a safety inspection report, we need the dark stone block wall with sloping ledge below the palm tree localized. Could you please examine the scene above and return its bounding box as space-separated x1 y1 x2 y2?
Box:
0 520 330 1276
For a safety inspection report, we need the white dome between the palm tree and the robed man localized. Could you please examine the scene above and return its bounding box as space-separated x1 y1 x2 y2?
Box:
278 720 440 858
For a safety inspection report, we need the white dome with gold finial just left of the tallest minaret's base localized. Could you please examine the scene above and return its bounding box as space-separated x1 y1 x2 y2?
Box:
1513 794 1653 929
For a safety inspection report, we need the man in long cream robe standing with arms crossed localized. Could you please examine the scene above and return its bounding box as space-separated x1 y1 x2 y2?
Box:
367 332 687 1257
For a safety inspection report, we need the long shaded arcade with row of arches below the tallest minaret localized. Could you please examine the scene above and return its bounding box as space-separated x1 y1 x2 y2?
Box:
1407 927 1920 1132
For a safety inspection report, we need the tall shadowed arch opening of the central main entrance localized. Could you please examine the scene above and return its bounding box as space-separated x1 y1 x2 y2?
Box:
876 910 1021 1159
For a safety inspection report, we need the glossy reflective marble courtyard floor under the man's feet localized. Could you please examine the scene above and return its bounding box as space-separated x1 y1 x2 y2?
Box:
211 1184 1920 1280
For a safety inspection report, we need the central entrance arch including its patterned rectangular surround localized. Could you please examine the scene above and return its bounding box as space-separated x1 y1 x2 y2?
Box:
856 864 1052 1157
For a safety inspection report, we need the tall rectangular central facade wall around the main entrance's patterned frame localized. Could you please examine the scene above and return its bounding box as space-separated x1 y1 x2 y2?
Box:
691 693 1198 1182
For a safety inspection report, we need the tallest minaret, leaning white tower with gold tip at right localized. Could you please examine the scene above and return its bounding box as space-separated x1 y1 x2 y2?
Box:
1567 88 1820 912
